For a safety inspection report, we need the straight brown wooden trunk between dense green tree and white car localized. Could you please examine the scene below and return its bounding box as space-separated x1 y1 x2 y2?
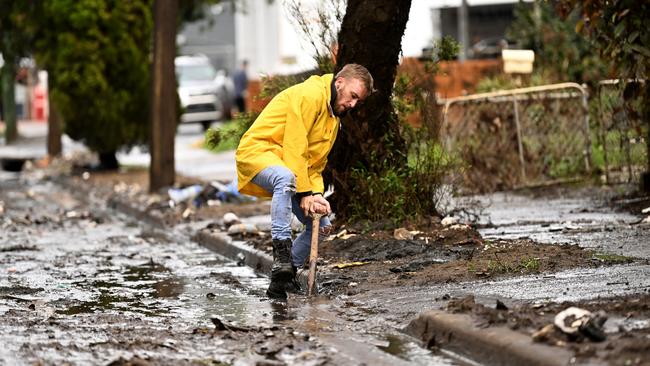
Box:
149 0 178 192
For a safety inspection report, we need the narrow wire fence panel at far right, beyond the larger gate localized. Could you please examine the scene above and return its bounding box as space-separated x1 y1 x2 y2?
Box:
594 79 647 183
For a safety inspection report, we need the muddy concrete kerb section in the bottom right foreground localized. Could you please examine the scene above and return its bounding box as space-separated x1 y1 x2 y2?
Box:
405 310 584 366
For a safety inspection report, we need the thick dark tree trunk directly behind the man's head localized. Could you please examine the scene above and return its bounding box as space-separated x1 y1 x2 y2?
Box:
325 0 411 218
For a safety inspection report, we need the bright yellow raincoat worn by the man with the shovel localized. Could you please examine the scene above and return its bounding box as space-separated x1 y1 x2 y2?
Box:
235 74 339 197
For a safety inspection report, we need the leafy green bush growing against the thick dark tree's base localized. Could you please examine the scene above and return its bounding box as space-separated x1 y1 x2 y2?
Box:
348 38 462 226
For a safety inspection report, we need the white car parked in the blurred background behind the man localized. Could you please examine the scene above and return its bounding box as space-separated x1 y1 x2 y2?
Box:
174 55 232 129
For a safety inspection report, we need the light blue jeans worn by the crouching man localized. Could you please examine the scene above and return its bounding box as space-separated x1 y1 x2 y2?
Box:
252 166 332 267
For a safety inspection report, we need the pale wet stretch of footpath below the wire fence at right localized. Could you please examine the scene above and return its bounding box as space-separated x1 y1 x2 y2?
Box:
474 186 650 259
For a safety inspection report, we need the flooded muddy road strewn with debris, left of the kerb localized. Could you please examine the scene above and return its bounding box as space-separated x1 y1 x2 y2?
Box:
0 174 459 365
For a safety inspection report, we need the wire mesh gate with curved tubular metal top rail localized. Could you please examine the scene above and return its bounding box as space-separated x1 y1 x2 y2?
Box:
439 83 591 192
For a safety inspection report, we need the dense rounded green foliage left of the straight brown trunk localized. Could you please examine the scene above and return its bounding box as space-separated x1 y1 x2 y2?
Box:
37 0 153 153
